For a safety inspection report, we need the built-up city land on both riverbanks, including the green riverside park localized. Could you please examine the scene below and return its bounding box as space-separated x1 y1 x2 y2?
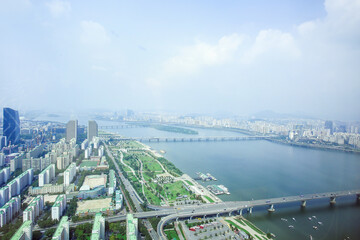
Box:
0 108 360 240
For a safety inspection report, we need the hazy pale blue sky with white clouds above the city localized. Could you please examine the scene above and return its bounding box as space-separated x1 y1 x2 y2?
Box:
0 0 360 120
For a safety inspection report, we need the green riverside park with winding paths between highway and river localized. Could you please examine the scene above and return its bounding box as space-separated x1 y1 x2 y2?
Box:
102 134 221 206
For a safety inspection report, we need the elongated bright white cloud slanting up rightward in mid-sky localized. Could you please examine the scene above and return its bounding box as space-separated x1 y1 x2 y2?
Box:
164 34 242 75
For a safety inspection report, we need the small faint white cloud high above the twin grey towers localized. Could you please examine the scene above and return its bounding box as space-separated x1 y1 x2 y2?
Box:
80 21 111 46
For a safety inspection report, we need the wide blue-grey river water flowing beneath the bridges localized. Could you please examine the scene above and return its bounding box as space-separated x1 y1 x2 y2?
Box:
34 115 360 240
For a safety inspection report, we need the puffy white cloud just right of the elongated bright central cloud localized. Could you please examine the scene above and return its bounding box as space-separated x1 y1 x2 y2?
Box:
241 29 301 63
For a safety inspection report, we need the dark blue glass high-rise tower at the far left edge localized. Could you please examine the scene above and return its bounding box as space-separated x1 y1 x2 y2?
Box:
3 108 20 144
